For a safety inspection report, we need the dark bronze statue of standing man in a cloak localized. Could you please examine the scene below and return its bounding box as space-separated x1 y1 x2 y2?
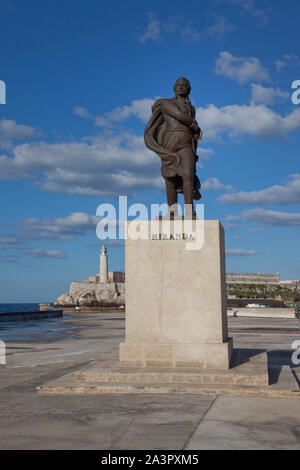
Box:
144 77 202 213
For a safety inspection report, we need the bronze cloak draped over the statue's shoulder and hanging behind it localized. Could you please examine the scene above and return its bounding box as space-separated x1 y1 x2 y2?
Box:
144 99 201 200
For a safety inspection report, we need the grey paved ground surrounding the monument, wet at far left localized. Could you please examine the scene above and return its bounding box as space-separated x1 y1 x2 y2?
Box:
0 313 300 450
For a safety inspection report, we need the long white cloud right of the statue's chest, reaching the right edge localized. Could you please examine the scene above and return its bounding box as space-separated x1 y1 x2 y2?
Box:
197 104 300 139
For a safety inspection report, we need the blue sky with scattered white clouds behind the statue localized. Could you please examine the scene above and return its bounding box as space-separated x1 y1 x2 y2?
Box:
0 0 300 302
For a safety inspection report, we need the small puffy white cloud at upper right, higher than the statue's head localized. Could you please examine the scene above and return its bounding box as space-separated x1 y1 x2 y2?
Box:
215 51 270 85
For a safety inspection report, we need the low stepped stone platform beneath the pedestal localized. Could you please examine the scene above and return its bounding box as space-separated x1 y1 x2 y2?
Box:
37 350 300 398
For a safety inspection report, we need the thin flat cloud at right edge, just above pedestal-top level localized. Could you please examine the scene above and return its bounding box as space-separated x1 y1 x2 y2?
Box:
243 208 300 227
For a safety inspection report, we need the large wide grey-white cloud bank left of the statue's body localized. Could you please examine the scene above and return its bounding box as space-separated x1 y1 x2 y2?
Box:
0 134 162 196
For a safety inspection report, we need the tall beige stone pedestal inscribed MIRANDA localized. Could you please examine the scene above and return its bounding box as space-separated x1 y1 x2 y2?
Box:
120 220 232 369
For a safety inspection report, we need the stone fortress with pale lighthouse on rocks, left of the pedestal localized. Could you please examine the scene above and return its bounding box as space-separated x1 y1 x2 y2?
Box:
54 246 125 307
